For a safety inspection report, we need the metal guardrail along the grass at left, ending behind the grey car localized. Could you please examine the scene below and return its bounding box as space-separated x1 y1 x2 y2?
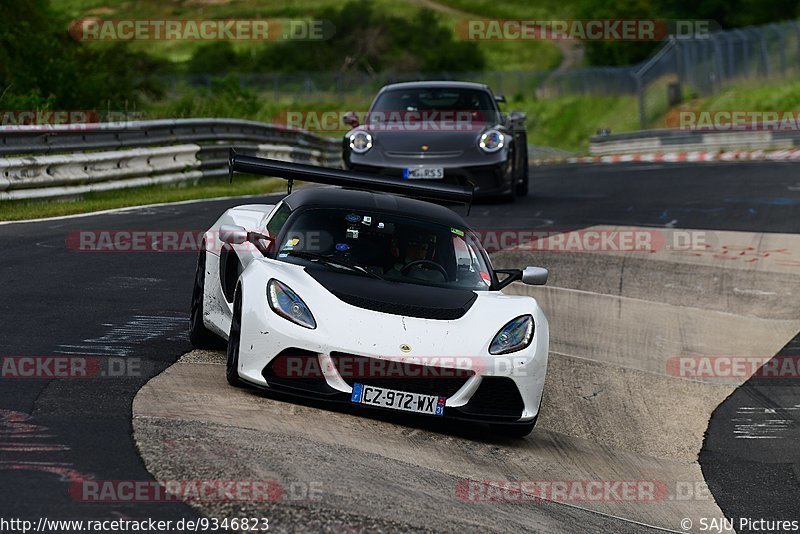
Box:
0 119 342 200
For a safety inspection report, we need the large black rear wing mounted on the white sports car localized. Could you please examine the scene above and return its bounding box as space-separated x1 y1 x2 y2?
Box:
228 149 473 204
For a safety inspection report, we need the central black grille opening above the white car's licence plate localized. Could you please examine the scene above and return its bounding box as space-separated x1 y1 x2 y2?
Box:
331 352 475 397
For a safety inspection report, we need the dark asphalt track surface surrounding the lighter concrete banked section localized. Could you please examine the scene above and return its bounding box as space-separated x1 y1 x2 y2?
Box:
0 162 800 531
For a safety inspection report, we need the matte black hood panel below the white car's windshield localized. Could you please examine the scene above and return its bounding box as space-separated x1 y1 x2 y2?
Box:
306 268 478 321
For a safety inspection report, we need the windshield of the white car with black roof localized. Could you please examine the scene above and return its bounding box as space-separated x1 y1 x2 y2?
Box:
277 209 491 291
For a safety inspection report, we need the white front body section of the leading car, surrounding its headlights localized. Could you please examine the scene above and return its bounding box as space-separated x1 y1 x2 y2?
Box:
237 266 549 430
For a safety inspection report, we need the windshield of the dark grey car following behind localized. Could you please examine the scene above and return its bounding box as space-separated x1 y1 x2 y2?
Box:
369 88 497 124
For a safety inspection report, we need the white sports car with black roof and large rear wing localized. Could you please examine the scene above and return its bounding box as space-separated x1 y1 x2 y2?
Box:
190 154 549 436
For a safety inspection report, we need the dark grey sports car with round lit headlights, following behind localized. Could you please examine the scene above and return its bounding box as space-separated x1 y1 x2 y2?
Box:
343 81 528 200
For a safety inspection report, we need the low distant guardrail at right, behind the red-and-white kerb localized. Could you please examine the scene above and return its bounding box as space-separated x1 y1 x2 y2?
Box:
589 129 800 156
